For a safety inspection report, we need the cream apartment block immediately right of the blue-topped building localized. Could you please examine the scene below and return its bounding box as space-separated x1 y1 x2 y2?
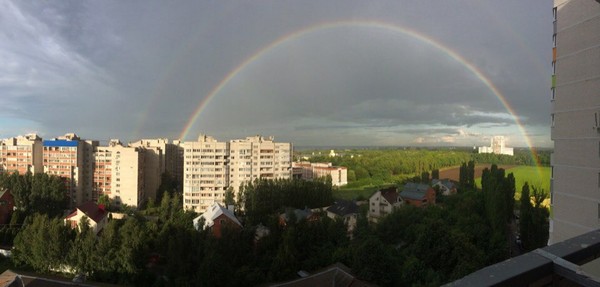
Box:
92 140 146 207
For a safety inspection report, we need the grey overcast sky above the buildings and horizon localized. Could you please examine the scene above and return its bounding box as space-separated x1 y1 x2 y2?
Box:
0 0 552 147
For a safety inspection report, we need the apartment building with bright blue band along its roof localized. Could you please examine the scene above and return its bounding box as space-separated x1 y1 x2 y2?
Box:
43 133 98 207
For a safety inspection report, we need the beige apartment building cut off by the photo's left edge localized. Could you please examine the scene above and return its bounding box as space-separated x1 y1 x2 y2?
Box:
0 134 44 174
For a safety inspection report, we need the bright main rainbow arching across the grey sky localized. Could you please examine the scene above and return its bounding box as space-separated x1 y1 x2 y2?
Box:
179 20 540 167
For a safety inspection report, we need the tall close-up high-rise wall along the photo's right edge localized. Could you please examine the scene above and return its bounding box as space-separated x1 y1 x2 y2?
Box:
550 0 600 243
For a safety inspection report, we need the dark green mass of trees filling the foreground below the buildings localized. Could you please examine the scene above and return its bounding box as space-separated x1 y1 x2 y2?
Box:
0 162 548 286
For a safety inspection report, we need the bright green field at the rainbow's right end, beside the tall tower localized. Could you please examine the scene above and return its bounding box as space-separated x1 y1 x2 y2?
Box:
475 166 551 199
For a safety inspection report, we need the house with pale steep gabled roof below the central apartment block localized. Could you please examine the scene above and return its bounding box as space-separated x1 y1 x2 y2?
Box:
193 202 242 238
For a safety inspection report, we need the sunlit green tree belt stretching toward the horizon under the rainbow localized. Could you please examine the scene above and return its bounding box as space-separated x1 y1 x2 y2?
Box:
295 149 550 199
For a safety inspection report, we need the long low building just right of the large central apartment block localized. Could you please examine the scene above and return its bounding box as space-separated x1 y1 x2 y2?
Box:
292 161 348 186
